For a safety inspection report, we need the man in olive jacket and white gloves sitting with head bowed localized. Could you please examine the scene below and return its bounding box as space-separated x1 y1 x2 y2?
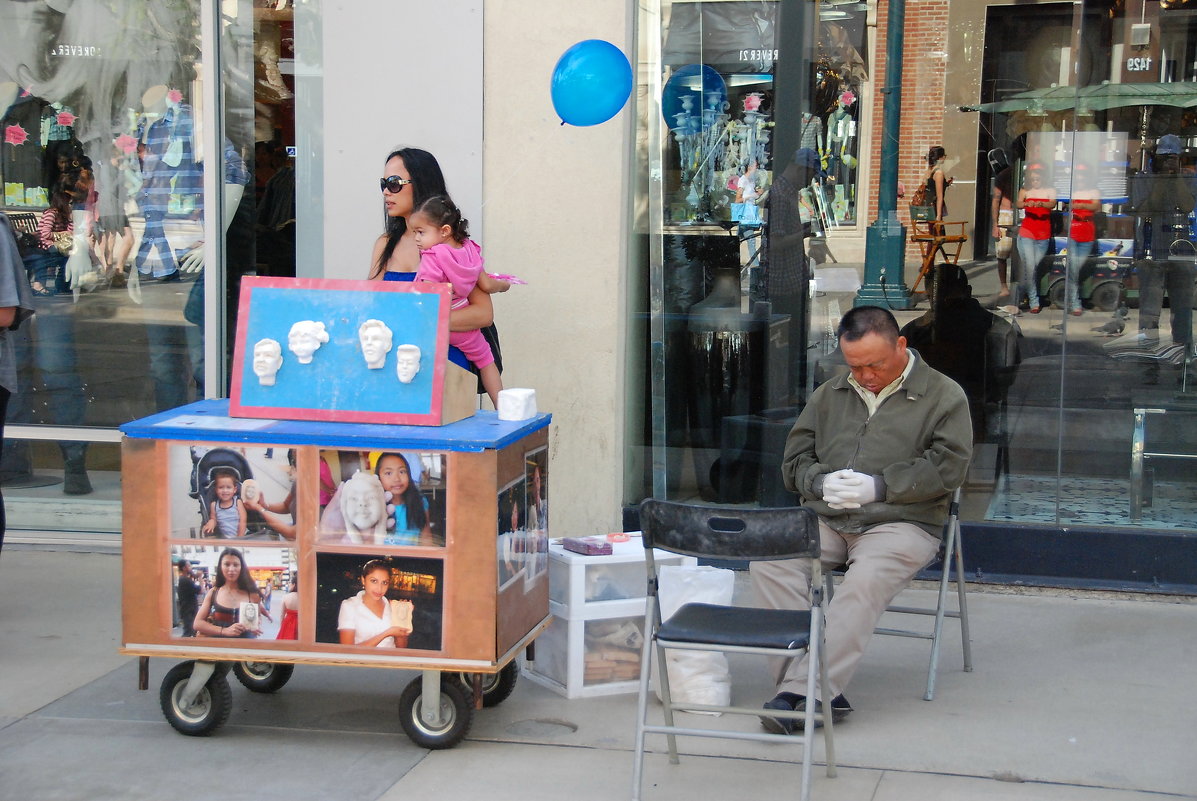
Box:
752 307 972 734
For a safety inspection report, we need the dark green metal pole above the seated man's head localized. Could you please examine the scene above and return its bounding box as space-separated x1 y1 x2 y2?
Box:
855 0 910 309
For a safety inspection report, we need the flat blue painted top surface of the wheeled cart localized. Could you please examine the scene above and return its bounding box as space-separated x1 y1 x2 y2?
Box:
121 399 553 453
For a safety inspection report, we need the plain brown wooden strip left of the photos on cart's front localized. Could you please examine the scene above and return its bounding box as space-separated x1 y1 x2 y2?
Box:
121 438 167 643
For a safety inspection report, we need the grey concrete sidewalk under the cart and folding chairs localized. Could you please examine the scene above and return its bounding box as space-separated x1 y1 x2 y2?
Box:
0 548 1197 801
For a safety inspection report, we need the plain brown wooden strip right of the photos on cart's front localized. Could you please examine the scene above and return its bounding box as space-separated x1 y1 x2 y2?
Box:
443 450 498 661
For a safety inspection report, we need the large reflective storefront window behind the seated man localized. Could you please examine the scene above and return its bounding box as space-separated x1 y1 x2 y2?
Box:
627 0 1197 562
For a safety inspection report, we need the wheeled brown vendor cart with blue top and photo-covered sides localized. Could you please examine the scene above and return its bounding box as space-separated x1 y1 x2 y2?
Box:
121 400 551 748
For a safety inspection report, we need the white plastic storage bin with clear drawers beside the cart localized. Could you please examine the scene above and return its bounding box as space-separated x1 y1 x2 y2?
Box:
525 533 697 698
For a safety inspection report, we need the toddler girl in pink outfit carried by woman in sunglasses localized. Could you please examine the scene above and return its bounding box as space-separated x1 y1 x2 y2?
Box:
407 195 510 408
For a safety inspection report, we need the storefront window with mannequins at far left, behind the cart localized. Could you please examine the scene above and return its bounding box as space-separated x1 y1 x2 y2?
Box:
0 0 296 530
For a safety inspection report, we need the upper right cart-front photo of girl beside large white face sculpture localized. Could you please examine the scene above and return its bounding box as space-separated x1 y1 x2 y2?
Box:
317 450 445 547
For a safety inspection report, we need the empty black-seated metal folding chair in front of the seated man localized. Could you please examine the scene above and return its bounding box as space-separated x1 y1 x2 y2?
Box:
632 499 836 801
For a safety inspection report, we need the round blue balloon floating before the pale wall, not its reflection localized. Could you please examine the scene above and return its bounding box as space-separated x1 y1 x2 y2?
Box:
551 40 632 126
